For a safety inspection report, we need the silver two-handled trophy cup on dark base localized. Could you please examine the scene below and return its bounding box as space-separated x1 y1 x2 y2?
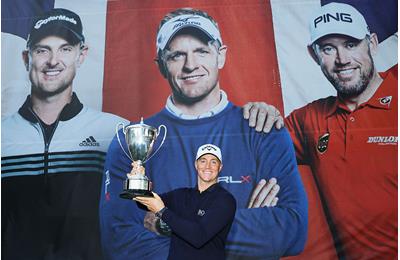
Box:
116 118 167 199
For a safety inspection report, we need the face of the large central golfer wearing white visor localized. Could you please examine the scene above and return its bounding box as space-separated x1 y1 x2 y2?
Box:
162 34 226 103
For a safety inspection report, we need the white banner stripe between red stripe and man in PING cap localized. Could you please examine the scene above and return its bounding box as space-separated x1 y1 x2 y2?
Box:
271 0 336 116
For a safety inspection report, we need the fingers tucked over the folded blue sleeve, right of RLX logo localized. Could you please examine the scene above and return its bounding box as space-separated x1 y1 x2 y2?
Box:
248 178 280 208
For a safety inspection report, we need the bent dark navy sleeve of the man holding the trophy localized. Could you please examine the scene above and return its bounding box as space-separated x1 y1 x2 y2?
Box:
162 194 236 248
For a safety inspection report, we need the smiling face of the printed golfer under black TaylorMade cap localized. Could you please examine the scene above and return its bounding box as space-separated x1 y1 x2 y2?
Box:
24 36 87 96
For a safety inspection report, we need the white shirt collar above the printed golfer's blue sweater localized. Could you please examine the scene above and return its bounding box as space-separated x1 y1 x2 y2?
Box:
165 90 229 120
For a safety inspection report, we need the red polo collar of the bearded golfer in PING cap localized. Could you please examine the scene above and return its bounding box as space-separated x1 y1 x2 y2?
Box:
327 70 397 117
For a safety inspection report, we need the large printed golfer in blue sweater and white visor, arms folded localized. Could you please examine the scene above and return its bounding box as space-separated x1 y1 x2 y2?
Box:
100 8 307 260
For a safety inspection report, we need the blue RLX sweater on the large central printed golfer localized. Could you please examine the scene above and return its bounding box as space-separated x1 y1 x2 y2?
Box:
100 103 307 260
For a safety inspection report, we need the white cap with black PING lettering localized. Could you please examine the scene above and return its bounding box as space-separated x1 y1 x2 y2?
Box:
310 3 370 45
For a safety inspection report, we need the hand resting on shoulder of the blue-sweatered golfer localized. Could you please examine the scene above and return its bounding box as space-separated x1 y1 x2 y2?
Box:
243 102 284 133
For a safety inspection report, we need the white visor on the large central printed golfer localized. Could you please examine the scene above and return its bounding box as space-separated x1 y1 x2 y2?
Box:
156 14 222 52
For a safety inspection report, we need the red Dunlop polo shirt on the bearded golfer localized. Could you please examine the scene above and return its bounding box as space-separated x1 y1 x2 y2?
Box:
286 66 397 259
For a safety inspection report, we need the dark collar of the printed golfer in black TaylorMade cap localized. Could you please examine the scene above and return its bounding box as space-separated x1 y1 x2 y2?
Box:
18 92 83 123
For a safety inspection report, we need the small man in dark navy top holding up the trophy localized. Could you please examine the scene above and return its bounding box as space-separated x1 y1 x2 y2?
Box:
134 144 236 260
